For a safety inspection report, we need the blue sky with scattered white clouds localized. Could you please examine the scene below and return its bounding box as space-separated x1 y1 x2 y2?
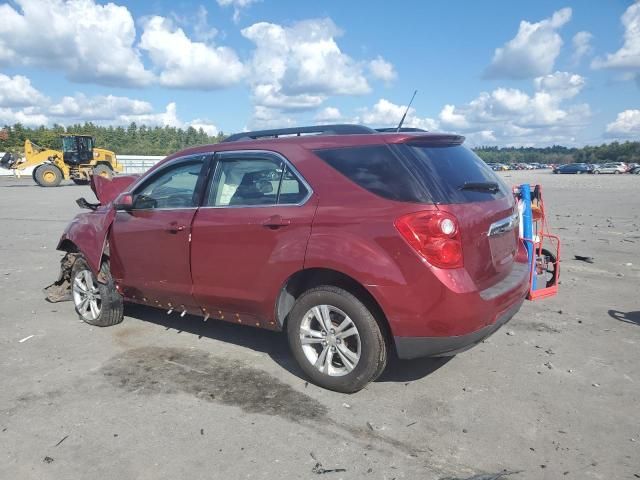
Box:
0 0 640 146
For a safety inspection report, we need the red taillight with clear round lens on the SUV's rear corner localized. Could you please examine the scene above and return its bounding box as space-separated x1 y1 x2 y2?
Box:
395 211 463 268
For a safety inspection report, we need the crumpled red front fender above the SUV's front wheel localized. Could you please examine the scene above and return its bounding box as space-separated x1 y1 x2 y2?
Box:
57 205 115 280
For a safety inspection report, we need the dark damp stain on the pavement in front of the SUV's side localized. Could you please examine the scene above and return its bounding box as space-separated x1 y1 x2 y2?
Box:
101 347 328 421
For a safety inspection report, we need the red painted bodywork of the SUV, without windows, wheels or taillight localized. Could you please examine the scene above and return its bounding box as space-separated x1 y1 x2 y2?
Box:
57 133 528 344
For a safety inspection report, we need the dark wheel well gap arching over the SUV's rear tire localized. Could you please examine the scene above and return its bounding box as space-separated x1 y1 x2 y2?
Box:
275 268 392 340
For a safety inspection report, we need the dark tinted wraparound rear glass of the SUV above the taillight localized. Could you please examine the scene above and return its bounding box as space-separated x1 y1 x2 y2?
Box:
315 144 509 204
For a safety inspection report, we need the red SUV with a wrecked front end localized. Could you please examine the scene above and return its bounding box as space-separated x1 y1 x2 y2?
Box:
49 125 528 392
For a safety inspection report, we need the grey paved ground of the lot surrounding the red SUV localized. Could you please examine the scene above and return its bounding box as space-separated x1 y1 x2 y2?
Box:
0 171 640 480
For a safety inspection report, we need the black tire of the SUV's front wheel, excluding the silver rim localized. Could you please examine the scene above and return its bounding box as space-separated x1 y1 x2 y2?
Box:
71 256 124 327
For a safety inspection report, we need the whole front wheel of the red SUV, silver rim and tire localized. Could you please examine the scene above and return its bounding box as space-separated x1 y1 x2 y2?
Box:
71 256 123 327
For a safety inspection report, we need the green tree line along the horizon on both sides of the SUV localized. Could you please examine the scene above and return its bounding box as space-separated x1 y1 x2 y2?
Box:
0 122 640 164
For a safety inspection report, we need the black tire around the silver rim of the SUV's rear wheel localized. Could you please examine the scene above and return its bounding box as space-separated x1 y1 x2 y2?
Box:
287 285 387 393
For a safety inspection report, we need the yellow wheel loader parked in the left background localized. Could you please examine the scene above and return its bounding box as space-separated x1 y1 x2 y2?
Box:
0 135 123 187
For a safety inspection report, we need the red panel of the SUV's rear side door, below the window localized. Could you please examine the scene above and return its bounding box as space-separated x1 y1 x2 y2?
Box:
191 197 317 321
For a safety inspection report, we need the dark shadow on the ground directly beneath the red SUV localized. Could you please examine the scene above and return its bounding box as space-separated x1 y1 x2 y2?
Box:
125 305 450 382
